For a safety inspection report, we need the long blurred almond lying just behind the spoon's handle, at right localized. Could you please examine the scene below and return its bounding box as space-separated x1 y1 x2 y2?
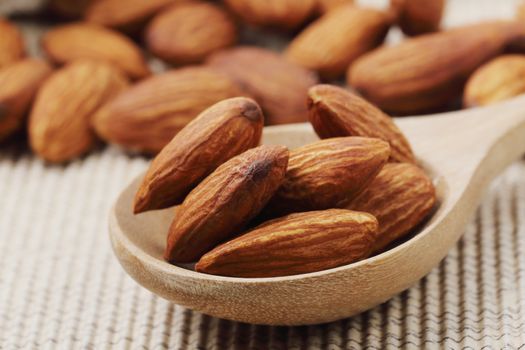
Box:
348 21 525 114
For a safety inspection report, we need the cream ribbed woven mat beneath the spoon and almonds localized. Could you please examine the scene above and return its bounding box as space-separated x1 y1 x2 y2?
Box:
0 0 525 350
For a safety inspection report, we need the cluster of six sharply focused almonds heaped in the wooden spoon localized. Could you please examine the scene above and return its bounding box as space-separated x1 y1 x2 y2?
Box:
134 85 436 277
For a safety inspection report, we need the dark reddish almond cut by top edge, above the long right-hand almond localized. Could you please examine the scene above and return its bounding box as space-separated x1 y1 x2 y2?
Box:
390 0 445 35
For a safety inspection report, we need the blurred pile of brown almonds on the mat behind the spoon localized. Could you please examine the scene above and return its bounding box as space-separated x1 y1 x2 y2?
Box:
0 0 525 163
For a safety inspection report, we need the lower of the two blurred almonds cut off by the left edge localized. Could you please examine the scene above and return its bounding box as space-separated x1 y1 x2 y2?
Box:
0 59 52 141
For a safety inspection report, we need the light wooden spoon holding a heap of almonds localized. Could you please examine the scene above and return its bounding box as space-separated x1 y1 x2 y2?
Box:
110 97 525 325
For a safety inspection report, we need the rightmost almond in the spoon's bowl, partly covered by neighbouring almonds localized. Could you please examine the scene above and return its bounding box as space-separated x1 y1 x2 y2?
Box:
347 163 436 253
